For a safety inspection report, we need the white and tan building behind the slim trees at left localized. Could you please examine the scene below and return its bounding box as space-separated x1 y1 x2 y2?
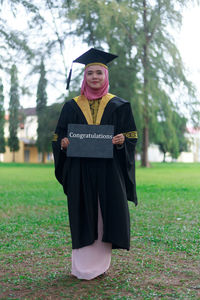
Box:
0 108 52 163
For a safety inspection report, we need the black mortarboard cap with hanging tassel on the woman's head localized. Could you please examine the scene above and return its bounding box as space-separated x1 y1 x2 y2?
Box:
67 48 118 90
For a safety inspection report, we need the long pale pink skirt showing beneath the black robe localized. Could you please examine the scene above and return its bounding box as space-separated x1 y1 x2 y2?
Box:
72 200 112 280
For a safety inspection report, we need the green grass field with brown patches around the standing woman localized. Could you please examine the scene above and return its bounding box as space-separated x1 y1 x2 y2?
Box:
0 163 200 300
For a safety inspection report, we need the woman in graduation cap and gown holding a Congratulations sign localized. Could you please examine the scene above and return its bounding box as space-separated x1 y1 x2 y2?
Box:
53 48 137 280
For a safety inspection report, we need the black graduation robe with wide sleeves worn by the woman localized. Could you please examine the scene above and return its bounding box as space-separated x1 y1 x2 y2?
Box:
52 96 137 250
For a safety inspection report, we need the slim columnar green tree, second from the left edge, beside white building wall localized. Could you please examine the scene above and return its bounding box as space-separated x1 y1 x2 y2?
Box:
8 65 20 162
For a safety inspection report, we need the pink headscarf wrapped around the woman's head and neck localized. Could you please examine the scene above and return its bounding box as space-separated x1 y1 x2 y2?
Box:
81 66 109 100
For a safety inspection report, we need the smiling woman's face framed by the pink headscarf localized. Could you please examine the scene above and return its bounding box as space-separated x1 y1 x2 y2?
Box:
86 65 105 89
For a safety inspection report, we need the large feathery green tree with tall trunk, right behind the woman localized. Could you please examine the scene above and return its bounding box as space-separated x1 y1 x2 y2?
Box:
66 0 198 166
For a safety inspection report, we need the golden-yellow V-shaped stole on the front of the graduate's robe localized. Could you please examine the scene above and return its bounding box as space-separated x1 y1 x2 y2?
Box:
74 93 115 125
